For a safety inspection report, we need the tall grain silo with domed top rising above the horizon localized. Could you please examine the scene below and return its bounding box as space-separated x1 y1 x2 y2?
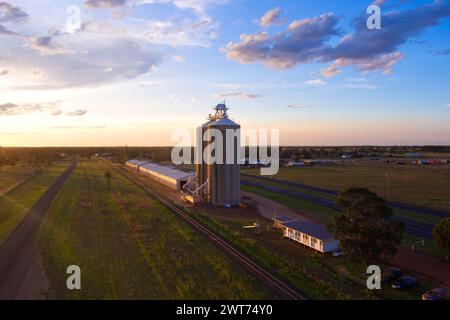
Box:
197 103 241 207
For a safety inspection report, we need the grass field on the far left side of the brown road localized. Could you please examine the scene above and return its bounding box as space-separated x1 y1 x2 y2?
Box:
0 161 70 244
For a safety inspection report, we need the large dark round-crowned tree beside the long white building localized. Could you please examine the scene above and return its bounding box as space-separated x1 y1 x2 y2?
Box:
329 188 404 263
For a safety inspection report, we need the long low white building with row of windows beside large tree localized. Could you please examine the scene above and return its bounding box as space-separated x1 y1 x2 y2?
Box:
283 221 339 253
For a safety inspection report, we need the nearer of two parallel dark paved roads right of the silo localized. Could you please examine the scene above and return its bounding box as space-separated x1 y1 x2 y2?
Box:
241 180 434 240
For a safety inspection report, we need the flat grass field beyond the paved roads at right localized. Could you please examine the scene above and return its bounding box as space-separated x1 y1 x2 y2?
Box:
242 163 450 211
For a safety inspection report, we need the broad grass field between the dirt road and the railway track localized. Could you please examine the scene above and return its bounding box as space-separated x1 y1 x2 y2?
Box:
38 161 276 299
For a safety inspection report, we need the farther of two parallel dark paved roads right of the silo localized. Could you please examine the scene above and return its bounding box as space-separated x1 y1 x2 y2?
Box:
242 174 450 218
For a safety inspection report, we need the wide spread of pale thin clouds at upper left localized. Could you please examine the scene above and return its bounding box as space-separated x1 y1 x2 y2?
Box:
0 0 226 90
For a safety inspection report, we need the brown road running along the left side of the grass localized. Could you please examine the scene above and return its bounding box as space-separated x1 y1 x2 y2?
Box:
0 161 77 300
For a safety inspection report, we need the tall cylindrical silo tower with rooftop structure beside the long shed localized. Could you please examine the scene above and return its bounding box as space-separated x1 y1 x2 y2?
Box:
200 103 241 207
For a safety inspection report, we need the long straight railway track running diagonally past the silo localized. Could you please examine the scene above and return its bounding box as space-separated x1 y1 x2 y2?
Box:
115 169 307 300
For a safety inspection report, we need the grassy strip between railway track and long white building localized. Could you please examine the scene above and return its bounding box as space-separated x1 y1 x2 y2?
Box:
187 212 428 300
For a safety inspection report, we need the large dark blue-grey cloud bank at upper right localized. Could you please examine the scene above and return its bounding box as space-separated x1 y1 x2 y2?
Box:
222 0 450 77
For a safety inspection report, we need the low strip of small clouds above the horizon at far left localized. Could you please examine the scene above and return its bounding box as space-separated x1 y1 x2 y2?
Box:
0 101 87 117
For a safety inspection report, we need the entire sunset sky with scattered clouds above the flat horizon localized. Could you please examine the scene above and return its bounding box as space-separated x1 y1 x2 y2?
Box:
0 0 450 146
